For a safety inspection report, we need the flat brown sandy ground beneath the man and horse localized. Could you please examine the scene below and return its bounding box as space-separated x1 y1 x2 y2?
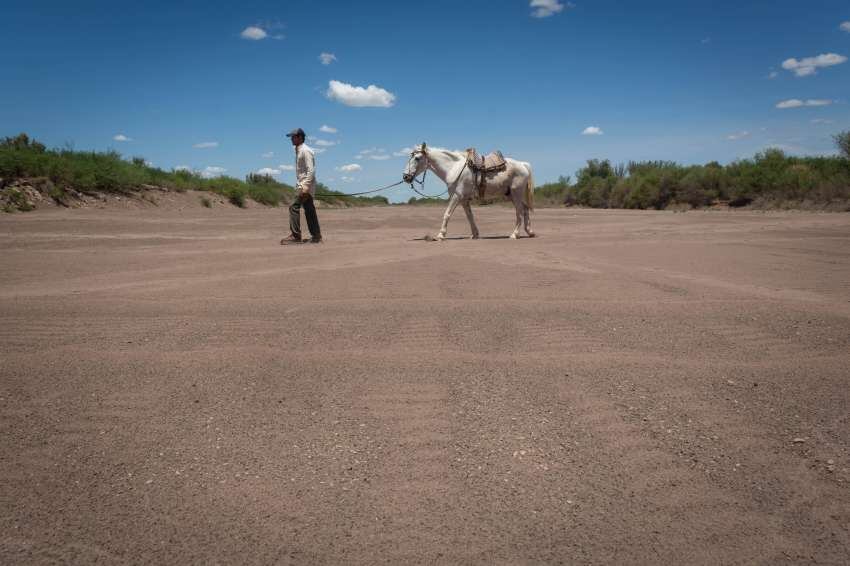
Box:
0 203 850 564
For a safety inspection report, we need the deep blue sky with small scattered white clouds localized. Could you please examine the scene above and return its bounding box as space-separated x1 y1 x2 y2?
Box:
0 0 850 200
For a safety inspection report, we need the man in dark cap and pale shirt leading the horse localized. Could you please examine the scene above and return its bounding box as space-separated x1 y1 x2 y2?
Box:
280 128 322 245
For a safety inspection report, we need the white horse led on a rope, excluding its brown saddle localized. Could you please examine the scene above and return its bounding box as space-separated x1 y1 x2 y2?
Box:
403 143 534 240
